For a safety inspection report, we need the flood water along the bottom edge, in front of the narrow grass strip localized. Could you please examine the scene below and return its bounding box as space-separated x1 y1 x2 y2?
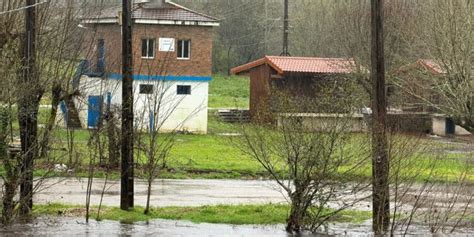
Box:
0 217 474 237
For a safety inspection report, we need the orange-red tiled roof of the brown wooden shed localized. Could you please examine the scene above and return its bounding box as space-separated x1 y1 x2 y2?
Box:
231 56 355 74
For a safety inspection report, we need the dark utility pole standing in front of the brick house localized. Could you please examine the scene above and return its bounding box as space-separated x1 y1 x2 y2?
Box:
120 0 134 211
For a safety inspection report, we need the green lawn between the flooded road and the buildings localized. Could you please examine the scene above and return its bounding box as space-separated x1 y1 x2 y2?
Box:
0 121 474 182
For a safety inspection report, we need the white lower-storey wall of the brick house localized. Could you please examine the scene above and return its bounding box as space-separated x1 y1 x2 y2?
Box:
76 77 209 133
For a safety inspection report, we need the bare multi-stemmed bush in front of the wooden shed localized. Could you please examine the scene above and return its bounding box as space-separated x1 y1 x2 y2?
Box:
233 80 369 233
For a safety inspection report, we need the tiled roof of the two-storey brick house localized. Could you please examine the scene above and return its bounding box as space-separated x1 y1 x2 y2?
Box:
83 2 218 22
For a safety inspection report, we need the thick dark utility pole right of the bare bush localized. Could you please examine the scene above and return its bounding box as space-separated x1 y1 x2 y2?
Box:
371 0 390 235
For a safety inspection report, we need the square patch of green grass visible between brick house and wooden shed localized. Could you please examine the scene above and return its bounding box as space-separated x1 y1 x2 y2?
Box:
209 75 250 108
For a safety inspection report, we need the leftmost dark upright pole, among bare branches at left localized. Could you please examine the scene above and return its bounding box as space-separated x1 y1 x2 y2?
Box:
18 0 39 216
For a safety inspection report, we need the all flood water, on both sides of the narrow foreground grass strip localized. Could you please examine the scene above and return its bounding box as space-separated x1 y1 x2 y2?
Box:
0 178 474 237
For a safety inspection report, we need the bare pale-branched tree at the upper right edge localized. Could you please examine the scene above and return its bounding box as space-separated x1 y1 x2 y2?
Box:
398 0 474 131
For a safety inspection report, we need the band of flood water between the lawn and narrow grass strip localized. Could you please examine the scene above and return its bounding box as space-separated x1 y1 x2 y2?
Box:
29 178 286 207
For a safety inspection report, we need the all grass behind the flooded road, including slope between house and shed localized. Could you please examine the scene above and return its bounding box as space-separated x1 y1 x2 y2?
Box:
0 75 474 181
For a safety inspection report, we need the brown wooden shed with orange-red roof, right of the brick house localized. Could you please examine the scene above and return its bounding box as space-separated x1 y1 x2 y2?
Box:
231 56 355 116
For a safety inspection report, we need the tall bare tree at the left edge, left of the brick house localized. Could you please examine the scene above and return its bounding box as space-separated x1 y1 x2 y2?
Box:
0 1 109 222
